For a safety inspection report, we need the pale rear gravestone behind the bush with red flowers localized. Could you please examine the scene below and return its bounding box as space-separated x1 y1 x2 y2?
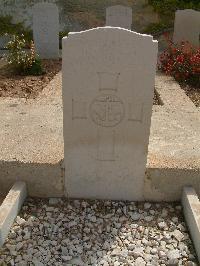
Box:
173 9 200 47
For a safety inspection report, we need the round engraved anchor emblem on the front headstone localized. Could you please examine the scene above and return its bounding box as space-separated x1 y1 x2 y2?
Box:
90 94 124 127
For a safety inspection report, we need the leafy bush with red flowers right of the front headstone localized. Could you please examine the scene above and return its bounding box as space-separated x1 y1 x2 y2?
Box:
159 33 200 88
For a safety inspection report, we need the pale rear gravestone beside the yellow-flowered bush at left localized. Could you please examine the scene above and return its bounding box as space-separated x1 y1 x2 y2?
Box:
33 3 59 59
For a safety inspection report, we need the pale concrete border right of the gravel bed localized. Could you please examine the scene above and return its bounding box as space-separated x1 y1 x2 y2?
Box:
182 187 200 262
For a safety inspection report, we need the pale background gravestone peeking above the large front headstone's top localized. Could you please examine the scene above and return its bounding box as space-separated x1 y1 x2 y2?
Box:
106 5 132 29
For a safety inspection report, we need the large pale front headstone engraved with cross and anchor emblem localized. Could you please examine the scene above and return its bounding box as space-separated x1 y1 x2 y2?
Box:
62 27 157 200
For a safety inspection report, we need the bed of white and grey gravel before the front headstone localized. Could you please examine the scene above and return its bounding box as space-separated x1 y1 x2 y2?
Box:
0 198 198 266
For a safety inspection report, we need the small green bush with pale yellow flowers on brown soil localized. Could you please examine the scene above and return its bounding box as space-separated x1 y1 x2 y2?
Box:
4 35 43 75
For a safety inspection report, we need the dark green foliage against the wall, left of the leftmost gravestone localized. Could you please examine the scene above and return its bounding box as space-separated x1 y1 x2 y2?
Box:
0 16 33 46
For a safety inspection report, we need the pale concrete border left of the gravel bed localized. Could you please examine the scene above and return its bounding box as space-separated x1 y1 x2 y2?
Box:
0 182 27 247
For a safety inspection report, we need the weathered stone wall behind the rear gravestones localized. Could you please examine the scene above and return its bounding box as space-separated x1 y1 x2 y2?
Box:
0 0 159 32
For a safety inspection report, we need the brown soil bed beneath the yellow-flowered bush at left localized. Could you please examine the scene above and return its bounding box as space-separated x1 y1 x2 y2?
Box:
0 60 62 98
